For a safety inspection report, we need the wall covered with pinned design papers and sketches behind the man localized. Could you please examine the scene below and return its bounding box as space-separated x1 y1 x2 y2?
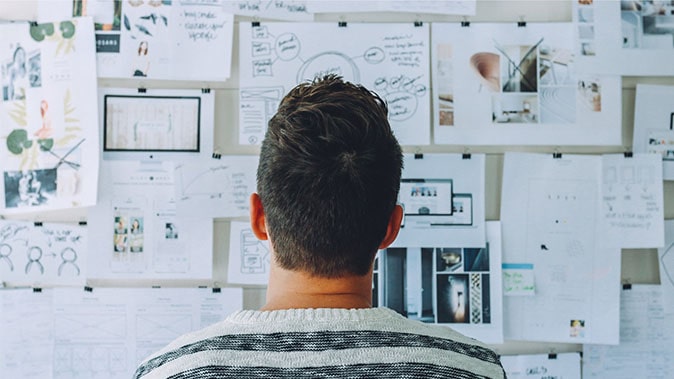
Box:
0 0 674 378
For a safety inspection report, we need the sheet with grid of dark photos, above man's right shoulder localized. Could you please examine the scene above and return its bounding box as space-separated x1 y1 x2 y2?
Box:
373 221 503 343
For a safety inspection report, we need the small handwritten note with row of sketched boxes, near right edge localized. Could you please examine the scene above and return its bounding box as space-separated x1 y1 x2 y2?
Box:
601 154 664 248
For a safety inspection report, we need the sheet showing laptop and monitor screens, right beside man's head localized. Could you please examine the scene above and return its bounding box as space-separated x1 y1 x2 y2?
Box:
392 154 486 247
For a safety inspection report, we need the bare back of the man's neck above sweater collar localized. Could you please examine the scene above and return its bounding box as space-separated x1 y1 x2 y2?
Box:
260 264 372 311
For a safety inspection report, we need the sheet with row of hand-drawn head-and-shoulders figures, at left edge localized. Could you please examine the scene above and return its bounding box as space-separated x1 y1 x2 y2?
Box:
0 221 86 284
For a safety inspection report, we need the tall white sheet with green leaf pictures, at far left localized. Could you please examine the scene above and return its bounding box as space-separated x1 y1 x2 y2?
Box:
0 17 99 214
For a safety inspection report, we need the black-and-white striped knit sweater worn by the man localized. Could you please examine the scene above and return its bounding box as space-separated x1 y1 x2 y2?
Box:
135 308 505 379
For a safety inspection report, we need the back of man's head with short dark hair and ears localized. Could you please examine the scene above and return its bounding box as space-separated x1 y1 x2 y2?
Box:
251 75 402 277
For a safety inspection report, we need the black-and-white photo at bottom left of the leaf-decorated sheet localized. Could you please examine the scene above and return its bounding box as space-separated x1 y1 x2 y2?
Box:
4 168 56 208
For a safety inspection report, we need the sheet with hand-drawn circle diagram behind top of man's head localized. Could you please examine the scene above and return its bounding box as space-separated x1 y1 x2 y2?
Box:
239 23 430 144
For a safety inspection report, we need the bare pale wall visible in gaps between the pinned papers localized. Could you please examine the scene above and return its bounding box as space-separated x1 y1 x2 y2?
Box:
0 0 674 354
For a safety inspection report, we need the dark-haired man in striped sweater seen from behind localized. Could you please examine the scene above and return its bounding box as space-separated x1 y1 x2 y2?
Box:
136 75 505 378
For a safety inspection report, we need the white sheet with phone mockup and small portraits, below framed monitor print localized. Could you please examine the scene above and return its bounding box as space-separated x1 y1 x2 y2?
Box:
88 161 213 279
